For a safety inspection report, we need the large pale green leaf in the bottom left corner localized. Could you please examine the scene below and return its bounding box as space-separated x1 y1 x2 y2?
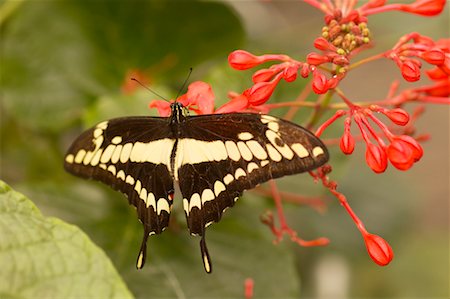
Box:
0 181 133 298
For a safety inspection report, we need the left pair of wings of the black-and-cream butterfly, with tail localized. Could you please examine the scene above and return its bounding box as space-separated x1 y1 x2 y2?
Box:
64 117 175 268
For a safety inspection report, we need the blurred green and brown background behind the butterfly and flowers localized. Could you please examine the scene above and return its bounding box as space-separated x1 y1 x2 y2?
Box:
0 0 450 298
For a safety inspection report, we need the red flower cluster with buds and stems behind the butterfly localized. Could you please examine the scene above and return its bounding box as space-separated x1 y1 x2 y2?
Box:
125 0 450 268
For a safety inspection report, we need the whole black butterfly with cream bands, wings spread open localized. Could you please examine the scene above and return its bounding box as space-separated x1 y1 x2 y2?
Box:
64 102 329 273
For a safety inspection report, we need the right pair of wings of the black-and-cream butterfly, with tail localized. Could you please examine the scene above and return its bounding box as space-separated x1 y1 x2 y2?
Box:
175 113 329 272
